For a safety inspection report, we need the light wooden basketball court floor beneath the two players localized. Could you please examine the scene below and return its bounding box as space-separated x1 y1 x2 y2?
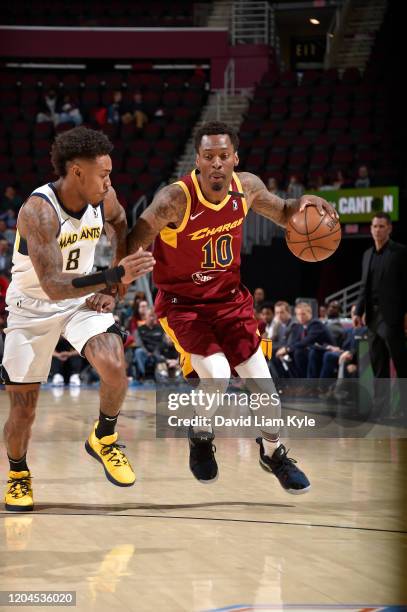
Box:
0 389 407 612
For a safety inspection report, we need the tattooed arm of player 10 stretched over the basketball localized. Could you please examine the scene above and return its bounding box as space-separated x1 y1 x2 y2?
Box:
239 172 338 227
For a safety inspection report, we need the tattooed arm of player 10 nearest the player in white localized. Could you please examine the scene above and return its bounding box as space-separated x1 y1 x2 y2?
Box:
127 185 187 253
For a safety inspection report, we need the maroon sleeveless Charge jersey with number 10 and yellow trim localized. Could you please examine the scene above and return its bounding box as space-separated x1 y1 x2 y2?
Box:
153 170 247 301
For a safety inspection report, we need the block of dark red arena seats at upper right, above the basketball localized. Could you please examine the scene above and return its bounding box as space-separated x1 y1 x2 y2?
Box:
240 5 401 185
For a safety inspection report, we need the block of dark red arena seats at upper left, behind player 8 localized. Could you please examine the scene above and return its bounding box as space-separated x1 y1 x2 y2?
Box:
0 71 207 207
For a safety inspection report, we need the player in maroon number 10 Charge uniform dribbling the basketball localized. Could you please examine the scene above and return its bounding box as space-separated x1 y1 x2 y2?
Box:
124 122 337 493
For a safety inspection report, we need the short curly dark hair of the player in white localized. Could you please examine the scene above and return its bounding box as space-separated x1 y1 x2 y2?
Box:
51 126 113 176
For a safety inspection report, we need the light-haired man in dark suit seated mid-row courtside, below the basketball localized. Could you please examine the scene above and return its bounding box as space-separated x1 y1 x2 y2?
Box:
276 302 332 378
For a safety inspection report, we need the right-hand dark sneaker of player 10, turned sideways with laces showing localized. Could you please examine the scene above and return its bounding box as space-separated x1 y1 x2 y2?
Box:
256 438 311 495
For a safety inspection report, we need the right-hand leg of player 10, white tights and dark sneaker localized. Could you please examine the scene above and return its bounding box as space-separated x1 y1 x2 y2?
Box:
235 348 311 495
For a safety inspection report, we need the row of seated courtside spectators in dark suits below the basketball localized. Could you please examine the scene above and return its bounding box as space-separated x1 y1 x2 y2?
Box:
253 287 367 399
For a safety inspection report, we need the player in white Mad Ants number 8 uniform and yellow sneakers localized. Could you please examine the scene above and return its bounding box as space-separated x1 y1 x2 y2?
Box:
2 127 154 511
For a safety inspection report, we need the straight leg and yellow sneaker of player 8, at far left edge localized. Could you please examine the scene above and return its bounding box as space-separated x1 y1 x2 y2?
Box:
4 381 40 512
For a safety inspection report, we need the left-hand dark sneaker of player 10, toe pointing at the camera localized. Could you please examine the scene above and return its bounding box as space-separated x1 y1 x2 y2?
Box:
188 427 218 484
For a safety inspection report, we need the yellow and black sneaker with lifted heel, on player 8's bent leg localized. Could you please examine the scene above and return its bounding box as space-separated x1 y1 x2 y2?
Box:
85 423 136 487
